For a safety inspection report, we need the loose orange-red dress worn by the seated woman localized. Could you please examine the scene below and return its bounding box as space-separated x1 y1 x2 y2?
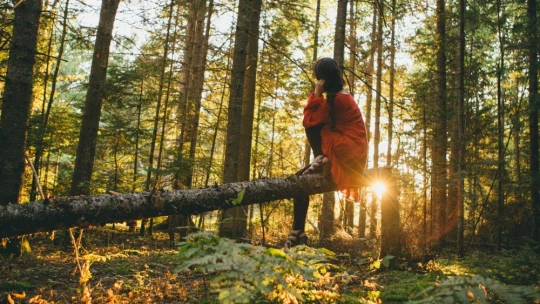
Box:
303 93 368 190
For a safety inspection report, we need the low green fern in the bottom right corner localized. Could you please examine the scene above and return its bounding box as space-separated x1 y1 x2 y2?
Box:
411 276 540 303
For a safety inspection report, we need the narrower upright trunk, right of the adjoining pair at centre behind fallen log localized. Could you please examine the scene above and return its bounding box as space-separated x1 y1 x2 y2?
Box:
238 0 262 181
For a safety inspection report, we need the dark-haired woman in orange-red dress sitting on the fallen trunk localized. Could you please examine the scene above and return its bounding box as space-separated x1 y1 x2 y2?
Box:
285 58 368 248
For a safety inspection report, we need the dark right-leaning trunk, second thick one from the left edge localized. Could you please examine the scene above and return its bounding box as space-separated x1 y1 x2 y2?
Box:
70 0 120 195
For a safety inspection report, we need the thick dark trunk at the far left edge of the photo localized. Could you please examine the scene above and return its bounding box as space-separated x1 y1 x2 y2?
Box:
0 0 41 205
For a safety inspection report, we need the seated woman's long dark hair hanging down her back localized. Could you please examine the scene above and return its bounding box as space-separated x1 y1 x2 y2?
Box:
313 58 343 131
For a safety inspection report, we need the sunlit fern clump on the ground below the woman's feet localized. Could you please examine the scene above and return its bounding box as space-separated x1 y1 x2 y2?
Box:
177 232 342 303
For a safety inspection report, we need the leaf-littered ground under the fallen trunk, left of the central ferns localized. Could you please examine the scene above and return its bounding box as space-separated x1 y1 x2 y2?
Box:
0 225 217 303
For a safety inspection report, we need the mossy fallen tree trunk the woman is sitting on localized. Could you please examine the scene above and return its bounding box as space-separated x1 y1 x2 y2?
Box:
0 168 389 237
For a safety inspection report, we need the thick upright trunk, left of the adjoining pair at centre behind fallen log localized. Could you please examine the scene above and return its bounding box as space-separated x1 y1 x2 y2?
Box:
219 0 252 238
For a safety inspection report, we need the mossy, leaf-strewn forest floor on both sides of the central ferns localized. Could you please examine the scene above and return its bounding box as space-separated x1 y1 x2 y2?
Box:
0 227 540 304
